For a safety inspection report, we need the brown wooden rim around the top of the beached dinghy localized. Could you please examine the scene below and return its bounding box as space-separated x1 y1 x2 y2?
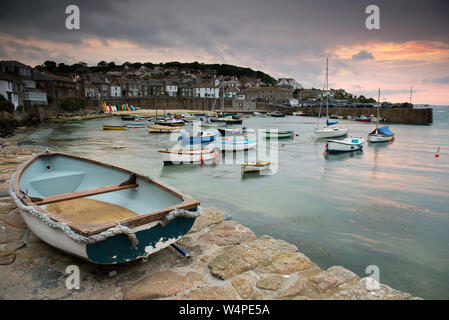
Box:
12 151 200 236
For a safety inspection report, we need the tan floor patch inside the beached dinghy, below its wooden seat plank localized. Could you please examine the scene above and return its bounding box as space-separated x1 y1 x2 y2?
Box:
46 198 138 225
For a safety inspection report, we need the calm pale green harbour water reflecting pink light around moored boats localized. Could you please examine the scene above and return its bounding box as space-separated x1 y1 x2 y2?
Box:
16 107 449 299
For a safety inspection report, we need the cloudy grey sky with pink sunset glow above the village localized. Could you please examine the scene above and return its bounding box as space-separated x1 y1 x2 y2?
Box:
0 0 449 105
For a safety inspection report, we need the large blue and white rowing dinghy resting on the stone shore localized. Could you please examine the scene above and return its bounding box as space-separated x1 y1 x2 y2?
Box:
9 151 200 264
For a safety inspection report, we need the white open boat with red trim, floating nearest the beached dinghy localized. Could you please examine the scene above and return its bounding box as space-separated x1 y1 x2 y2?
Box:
158 148 218 164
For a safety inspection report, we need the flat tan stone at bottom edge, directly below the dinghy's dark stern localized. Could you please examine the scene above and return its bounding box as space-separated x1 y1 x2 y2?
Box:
123 270 203 300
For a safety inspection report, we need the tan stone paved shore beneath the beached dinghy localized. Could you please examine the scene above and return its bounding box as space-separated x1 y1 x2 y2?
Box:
0 140 417 300
